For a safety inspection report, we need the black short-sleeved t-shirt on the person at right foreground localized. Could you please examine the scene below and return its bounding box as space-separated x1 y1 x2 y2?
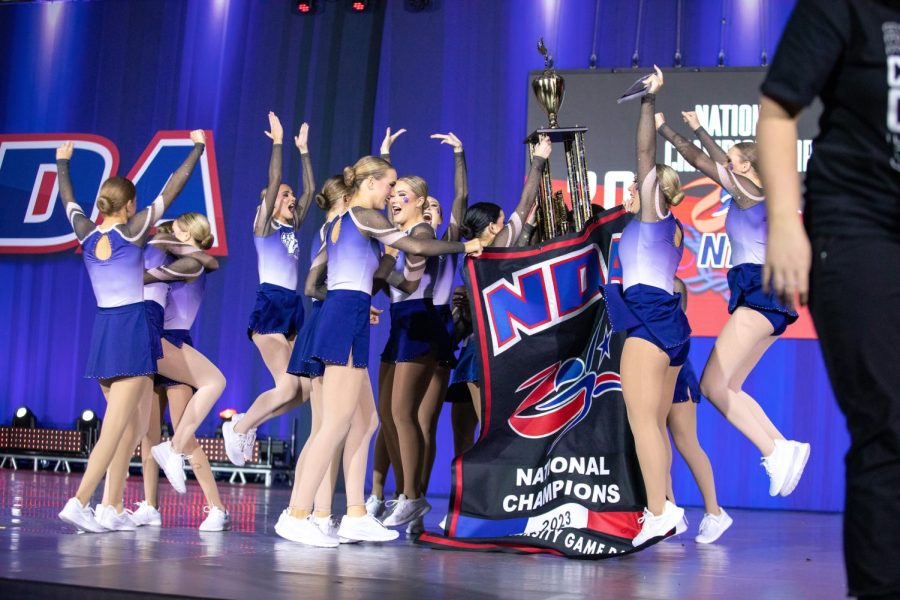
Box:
762 0 900 236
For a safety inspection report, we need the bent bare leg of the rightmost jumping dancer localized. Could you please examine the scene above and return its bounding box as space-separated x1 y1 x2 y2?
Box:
700 307 781 456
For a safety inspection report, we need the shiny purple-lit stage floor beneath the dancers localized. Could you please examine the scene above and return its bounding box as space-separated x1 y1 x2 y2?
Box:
0 469 845 600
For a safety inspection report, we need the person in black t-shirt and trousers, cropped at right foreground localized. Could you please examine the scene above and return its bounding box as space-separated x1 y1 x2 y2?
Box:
757 0 900 598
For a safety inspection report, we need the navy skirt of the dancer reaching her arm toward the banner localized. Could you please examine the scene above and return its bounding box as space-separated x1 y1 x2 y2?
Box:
310 290 372 369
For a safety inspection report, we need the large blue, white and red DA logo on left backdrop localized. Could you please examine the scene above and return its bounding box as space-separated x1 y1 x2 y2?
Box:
0 131 228 256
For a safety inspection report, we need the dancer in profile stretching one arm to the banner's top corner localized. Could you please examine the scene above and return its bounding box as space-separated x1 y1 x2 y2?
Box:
280 156 481 547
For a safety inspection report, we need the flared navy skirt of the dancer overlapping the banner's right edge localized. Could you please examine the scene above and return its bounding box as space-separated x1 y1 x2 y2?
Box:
603 283 691 367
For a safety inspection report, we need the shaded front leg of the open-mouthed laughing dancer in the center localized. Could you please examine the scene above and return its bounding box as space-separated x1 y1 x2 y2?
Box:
391 358 435 500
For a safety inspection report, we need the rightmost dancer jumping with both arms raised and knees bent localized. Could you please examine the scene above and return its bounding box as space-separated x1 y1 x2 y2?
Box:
657 102 810 496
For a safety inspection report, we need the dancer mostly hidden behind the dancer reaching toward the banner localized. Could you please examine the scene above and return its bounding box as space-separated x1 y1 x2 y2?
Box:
275 175 349 537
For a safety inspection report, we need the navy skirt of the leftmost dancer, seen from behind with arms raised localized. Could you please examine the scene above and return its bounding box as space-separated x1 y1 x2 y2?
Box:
84 301 156 379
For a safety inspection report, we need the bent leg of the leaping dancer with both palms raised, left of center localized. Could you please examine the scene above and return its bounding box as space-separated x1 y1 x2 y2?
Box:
234 333 300 434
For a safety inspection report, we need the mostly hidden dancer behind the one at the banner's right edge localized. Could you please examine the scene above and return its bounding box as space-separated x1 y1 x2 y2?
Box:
666 278 732 544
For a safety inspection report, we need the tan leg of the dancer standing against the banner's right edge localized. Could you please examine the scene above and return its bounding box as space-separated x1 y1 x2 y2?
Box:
621 337 677 515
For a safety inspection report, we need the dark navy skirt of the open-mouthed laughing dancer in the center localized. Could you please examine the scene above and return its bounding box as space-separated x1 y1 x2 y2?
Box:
381 298 454 365
